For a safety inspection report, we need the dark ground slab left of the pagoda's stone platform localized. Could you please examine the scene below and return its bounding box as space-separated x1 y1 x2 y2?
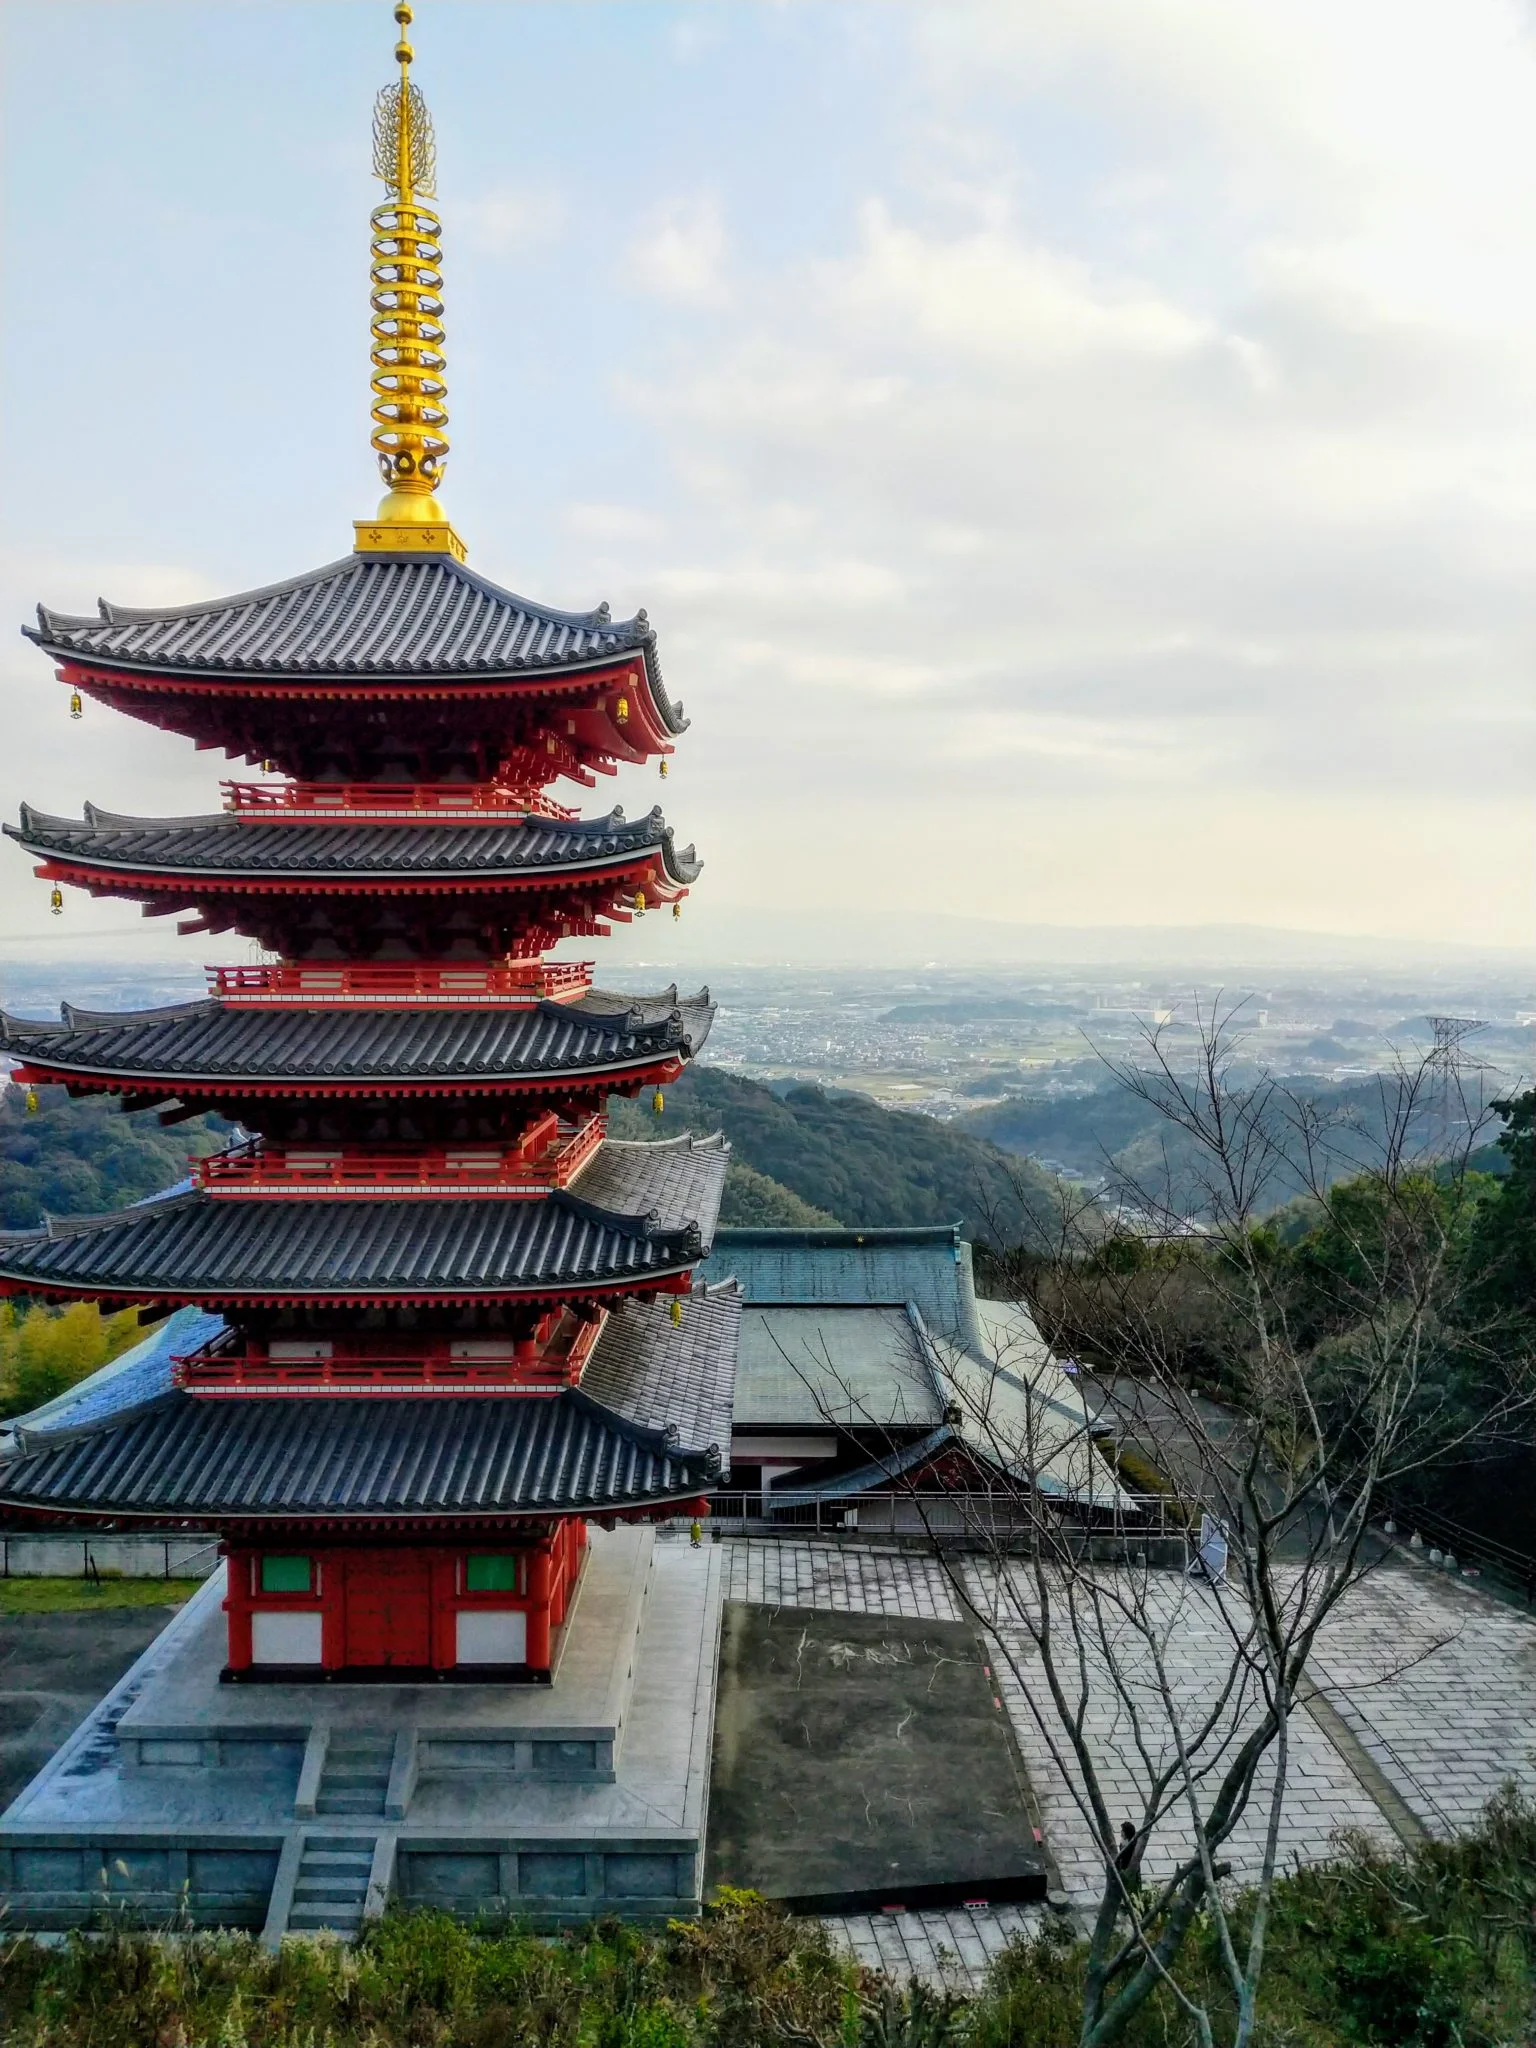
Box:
0 1608 178 1812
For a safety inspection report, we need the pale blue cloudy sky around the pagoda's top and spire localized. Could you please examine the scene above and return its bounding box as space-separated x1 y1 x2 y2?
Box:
0 0 1536 958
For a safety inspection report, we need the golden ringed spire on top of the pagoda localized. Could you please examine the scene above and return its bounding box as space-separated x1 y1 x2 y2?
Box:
356 0 465 561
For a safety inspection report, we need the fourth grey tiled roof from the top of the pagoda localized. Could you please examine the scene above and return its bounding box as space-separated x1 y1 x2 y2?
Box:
0 1139 727 1305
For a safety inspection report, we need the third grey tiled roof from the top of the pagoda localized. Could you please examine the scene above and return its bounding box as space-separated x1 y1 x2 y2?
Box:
0 989 715 1094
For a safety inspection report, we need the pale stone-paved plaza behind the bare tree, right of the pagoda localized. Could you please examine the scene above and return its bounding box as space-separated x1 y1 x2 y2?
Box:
723 1538 1536 1985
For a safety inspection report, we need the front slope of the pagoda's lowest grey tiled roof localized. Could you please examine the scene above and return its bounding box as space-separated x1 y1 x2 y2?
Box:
0 1391 719 1522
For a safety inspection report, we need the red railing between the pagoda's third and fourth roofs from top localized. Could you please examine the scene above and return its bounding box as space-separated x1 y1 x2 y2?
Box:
197 1110 608 1198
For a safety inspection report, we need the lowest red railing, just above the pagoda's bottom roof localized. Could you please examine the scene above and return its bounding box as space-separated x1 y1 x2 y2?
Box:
172 1311 606 1397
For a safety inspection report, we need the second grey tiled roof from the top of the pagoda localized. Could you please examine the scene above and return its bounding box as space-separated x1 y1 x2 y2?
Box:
0 803 702 885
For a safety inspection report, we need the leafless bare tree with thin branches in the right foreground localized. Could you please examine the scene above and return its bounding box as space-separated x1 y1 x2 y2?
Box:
786 1006 1532 2048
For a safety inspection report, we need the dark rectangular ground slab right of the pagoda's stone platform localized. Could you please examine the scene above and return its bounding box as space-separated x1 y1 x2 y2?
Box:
707 1602 1047 1913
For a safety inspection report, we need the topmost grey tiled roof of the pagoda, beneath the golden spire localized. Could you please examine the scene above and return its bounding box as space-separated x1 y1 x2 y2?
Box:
23 555 688 733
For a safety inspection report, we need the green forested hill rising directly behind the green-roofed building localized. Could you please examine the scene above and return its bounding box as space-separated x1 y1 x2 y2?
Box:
612 1067 1055 1243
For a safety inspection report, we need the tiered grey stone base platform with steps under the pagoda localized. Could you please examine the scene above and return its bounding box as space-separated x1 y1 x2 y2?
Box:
0 1530 721 1939
